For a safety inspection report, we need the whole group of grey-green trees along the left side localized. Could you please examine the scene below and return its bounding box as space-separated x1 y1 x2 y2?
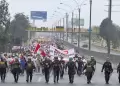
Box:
0 0 30 52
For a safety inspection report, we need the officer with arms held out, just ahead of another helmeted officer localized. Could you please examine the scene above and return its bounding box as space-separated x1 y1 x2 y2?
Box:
83 61 95 84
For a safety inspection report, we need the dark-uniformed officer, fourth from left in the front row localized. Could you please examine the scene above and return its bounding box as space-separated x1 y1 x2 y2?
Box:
43 57 51 83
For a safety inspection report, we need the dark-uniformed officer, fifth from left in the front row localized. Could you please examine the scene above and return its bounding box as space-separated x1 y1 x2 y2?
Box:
52 57 60 83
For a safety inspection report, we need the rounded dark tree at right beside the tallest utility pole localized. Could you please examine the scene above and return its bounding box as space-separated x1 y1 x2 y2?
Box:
99 18 119 55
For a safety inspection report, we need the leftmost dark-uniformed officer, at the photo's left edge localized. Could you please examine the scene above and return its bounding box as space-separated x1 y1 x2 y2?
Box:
0 58 8 82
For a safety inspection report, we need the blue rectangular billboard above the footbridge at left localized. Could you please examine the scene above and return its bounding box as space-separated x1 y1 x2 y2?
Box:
31 11 47 20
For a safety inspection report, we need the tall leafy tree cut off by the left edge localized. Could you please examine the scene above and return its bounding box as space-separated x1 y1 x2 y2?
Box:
0 0 10 52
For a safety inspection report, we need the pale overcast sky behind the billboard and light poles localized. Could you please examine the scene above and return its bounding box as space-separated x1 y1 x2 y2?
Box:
7 0 120 28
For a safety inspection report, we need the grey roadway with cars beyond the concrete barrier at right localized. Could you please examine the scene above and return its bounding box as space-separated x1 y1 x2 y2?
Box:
68 38 120 55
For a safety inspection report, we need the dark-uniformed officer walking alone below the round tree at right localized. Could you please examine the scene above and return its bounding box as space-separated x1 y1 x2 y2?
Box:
101 57 113 84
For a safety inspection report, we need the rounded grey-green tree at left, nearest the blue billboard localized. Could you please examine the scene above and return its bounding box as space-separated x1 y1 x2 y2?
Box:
10 13 30 44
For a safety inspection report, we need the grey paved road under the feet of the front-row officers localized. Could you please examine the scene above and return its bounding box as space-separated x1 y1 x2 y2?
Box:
0 64 119 86
